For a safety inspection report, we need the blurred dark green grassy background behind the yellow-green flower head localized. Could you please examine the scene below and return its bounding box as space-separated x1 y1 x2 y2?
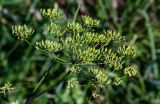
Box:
0 0 160 104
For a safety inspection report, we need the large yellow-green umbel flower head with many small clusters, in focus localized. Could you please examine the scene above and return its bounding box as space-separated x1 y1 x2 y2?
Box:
12 9 137 100
